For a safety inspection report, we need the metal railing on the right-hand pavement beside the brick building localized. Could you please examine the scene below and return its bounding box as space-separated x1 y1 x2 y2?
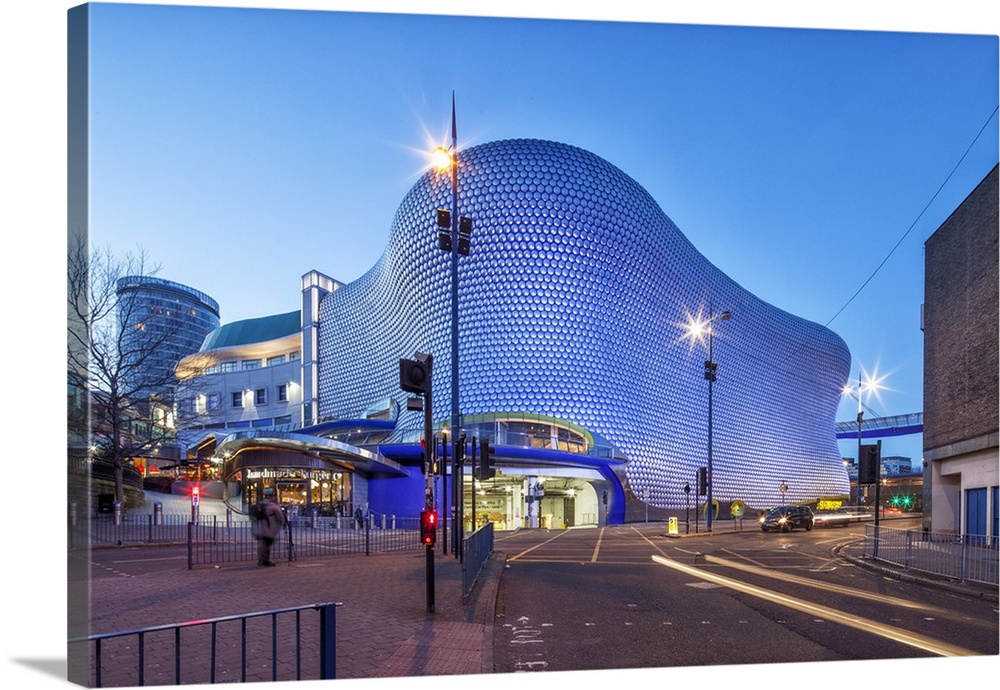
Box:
862 525 998 586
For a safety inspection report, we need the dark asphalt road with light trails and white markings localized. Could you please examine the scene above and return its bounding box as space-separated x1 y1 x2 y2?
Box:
494 523 998 673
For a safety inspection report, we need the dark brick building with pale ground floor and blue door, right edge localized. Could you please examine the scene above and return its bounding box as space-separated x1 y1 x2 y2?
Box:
922 167 1000 543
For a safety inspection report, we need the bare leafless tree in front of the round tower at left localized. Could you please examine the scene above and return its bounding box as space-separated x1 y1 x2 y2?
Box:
67 240 182 501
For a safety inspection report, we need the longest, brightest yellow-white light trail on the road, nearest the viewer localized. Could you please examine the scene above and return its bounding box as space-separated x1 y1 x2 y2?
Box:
650 555 981 656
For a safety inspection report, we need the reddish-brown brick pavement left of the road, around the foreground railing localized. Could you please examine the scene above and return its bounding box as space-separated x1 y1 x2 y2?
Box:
79 552 502 686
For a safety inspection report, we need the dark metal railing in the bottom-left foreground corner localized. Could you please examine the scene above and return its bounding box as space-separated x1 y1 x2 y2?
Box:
69 602 340 688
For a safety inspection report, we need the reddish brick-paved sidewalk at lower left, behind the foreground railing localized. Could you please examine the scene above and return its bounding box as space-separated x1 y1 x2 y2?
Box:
84 548 503 686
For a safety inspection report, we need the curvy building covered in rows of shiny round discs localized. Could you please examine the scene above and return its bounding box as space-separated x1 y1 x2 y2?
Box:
317 139 850 517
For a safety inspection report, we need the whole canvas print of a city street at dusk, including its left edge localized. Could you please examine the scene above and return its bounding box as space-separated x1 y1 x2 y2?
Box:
66 3 1000 687
